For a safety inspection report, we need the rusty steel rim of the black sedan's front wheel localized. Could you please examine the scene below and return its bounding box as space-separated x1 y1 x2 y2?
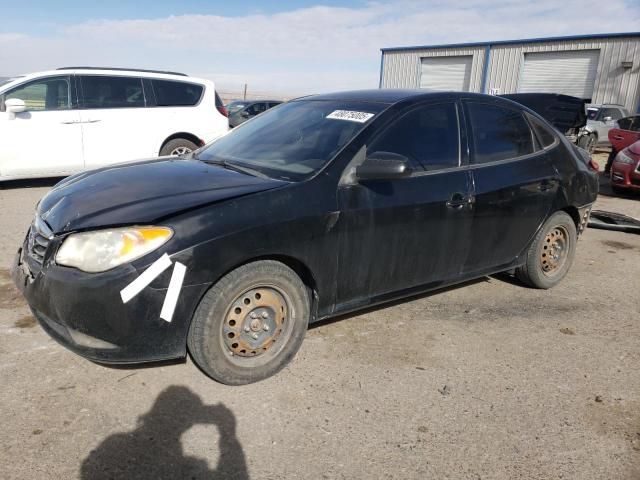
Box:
222 287 288 357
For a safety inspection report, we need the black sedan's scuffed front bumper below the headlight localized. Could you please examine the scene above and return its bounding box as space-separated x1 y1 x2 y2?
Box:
11 244 207 364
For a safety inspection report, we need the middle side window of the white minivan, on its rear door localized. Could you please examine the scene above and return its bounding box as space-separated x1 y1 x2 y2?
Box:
80 75 144 108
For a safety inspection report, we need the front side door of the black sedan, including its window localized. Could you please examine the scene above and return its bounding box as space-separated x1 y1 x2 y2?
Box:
337 101 472 309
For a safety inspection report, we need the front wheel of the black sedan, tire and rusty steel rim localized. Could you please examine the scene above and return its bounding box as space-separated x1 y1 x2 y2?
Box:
187 260 310 385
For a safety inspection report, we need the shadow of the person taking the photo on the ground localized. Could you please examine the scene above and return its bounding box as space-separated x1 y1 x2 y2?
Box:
80 386 249 480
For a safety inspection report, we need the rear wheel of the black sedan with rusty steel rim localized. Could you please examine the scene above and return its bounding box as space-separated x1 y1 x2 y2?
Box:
516 212 578 289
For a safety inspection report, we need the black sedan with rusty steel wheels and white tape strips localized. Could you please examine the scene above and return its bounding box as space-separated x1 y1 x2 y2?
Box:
13 90 598 384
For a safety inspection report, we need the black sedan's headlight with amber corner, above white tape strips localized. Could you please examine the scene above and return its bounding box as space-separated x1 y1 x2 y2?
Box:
56 227 173 273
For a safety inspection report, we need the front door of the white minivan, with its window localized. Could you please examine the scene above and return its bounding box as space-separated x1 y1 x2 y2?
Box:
0 75 83 177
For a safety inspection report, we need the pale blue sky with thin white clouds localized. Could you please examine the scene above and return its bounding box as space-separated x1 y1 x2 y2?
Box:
0 0 640 95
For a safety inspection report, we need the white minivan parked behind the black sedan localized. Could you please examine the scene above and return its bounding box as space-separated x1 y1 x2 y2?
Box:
0 67 229 181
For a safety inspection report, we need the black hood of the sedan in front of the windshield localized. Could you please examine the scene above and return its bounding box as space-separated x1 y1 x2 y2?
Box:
37 157 286 233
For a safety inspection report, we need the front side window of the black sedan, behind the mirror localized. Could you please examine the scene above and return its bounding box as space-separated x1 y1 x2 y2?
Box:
367 103 460 171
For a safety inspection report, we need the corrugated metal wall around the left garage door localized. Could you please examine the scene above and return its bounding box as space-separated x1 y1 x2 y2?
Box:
381 47 484 92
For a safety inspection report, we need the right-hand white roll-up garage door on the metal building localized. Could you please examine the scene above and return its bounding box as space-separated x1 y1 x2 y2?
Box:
518 50 600 98
